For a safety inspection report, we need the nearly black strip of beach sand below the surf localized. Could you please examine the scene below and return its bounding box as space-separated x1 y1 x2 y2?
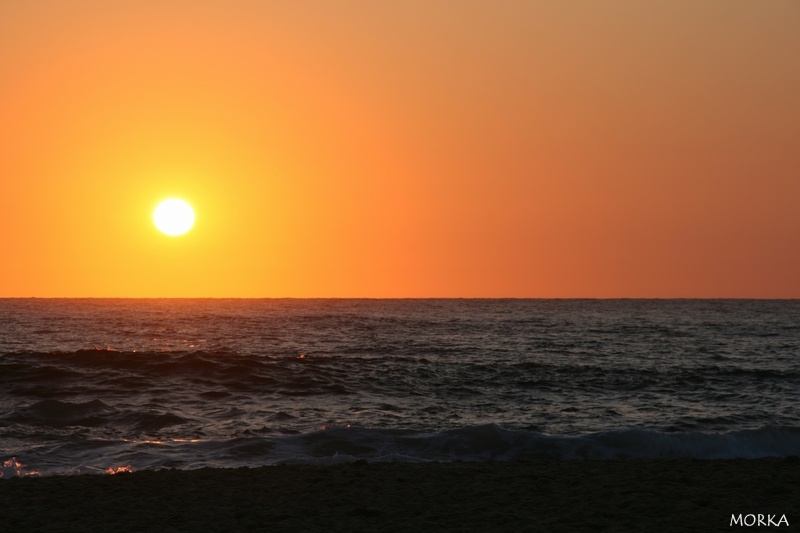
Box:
0 457 800 533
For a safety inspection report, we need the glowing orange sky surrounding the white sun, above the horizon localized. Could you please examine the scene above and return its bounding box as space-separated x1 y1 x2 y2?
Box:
0 0 800 298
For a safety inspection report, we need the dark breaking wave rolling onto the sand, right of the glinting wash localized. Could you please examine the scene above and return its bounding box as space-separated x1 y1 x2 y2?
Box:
280 424 800 462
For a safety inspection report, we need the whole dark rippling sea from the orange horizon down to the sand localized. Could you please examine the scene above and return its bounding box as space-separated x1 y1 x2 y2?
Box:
0 299 800 477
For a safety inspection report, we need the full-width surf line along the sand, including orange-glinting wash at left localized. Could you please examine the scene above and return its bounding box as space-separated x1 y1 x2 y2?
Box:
0 424 800 477
